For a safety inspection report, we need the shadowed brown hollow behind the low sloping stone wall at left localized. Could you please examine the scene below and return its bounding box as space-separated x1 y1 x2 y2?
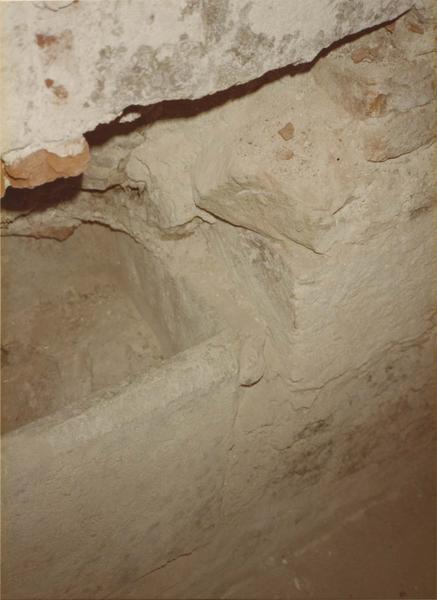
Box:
2 205 220 431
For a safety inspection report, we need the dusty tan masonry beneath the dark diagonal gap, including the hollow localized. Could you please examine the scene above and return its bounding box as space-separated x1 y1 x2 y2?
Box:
2 6 437 600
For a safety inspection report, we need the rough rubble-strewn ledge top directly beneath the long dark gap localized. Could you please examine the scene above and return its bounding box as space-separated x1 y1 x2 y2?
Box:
120 8 436 253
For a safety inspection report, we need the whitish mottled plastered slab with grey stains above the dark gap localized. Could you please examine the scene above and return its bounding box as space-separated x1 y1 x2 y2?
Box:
0 0 412 187
